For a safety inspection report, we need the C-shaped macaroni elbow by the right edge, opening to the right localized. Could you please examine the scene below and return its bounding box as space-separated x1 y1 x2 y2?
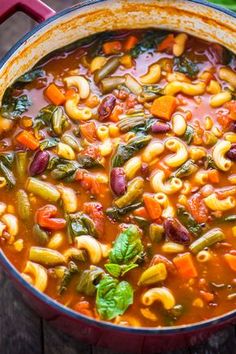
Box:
212 140 232 171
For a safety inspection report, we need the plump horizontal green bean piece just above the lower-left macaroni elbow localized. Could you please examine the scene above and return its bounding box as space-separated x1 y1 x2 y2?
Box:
29 246 66 267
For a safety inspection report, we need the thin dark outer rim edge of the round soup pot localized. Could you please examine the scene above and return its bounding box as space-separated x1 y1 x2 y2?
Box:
0 0 236 335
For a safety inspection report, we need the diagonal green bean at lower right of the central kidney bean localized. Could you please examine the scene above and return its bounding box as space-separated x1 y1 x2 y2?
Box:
114 177 144 208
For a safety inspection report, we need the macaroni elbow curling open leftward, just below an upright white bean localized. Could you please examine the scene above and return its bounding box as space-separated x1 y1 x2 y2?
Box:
165 138 188 167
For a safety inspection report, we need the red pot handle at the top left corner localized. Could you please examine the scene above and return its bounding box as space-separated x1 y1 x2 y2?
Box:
0 0 56 23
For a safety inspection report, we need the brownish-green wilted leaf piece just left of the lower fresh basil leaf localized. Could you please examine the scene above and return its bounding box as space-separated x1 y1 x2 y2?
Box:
76 265 105 296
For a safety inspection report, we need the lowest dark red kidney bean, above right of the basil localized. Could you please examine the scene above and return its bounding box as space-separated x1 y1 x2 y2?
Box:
163 218 190 245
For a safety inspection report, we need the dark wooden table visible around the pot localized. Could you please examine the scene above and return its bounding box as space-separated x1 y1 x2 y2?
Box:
0 0 236 354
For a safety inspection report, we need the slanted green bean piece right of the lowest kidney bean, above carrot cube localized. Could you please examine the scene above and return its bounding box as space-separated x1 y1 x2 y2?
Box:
189 228 225 254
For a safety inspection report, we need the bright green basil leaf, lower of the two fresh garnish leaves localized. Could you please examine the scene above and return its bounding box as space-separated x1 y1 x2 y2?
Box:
96 275 133 320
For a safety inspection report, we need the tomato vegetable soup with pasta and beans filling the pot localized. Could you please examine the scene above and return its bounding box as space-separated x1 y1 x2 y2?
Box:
0 29 236 327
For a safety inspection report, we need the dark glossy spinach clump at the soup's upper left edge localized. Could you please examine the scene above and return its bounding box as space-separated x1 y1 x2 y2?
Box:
0 88 32 119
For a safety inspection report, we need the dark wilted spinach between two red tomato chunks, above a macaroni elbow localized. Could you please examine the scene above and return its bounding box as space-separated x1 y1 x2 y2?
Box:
67 212 97 242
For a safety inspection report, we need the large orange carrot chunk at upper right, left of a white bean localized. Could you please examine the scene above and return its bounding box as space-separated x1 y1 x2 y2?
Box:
150 95 177 120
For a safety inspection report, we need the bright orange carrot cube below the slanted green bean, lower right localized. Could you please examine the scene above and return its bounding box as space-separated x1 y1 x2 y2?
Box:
173 252 198 279
